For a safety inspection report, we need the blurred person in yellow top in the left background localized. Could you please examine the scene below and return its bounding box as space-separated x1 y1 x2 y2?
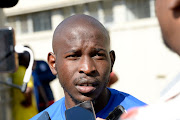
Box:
11 52 38 120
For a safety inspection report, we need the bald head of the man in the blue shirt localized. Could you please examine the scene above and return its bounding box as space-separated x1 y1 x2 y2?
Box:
48 15 115 107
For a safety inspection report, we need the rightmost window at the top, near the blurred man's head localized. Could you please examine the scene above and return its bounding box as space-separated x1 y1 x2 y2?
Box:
125 0 150 21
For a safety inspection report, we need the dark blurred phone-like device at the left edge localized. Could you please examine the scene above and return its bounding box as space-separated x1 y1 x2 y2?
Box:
0 27 18 73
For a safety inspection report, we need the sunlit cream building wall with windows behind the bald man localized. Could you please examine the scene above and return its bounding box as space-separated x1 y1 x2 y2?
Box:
5 0 180 103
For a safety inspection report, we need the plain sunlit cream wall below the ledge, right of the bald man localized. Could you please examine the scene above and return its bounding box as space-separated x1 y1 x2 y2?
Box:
111 18 180 103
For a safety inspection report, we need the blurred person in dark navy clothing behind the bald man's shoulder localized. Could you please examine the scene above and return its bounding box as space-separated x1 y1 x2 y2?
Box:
32 60 56 112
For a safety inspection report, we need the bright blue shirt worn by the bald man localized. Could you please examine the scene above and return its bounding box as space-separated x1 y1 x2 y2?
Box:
30 88 146 120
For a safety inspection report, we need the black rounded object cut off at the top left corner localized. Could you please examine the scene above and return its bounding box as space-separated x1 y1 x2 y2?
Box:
0 0 18 8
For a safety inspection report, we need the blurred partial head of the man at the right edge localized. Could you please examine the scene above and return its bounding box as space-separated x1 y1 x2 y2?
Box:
156 0 180 55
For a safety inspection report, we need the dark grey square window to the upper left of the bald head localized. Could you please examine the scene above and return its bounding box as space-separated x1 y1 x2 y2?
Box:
32 11 52 32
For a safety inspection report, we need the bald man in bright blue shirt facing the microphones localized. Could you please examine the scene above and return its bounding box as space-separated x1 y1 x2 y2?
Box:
32 15 146 120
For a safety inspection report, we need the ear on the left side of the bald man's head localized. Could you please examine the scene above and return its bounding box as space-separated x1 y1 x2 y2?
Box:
47 52 57 75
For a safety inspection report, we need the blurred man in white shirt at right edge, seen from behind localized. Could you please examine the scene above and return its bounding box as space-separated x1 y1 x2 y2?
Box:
118 0 180 120
